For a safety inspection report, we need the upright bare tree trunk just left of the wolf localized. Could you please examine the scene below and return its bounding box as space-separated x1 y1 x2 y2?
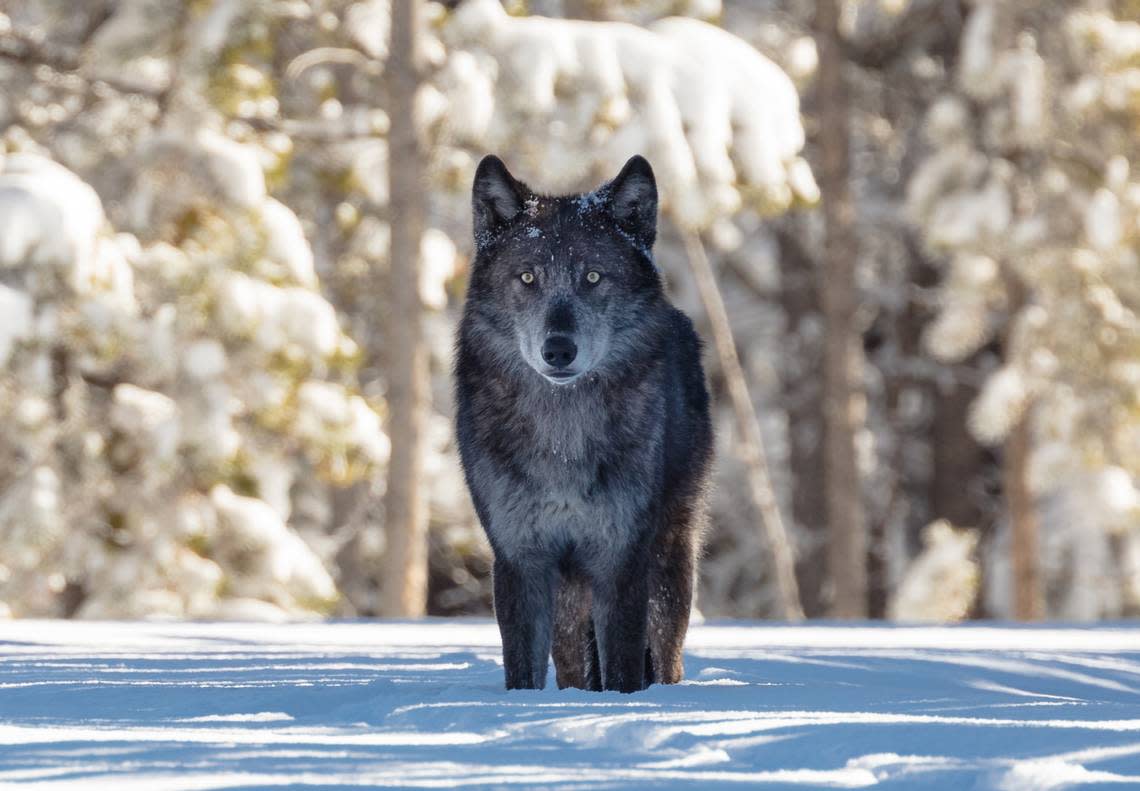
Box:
380 0 429 618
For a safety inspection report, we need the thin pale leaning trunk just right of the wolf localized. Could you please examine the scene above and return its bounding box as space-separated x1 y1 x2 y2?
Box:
685 233 804 621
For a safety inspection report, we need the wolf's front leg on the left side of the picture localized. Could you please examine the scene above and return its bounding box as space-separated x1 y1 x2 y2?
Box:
494 558 554 690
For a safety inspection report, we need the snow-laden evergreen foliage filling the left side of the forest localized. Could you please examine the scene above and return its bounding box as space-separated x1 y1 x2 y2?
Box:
0 0 389 618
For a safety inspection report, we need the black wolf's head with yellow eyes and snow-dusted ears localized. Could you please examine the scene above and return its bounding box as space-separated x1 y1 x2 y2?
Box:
467 156 661 384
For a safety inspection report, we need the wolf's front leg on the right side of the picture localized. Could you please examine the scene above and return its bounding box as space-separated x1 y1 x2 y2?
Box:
594 552 649 692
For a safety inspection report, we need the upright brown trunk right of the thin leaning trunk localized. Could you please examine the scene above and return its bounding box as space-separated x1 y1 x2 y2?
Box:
815 0 868 618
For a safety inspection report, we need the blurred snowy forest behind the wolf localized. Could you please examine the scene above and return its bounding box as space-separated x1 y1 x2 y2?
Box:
0 0 1140 620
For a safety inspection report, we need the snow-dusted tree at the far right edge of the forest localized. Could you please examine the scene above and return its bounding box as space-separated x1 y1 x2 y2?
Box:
909 0 1140 618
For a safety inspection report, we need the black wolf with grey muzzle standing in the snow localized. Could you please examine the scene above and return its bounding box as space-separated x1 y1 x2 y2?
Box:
455 155 713 692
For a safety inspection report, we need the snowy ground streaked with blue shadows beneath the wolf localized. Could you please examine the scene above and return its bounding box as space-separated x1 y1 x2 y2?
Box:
0 621 1140 791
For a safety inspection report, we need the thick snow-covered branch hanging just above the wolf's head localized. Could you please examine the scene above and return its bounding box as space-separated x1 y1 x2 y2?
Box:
422 0 819 229
